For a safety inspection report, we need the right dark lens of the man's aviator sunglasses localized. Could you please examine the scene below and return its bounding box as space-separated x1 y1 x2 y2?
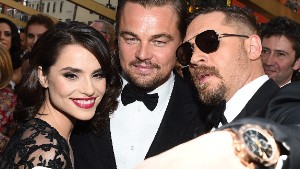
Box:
195 30 219 54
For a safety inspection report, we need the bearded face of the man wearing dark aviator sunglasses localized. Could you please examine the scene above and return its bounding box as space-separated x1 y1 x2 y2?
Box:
188 12 250 104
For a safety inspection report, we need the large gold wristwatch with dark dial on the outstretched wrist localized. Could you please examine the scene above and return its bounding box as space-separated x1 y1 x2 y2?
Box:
226 124 280 169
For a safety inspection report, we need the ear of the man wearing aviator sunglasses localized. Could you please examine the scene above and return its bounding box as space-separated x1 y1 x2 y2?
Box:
245 35 262 60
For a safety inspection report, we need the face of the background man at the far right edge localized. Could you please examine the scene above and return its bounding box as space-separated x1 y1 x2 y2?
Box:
261 36 300 86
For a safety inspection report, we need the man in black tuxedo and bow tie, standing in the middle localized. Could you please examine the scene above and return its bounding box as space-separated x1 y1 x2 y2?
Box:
71 0 205 169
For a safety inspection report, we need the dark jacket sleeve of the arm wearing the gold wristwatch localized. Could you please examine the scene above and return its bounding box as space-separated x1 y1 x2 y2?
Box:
221 82 300 169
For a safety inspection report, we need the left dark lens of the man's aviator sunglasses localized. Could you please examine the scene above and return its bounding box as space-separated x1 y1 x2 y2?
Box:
176 42 193 66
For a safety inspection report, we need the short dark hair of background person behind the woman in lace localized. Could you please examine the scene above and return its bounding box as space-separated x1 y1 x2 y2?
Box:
25 14 54 34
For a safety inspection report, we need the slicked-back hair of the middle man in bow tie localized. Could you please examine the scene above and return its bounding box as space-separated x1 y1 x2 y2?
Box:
116 0 187 39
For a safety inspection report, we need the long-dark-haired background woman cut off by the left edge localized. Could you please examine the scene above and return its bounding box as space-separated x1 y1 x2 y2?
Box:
0 18 22 88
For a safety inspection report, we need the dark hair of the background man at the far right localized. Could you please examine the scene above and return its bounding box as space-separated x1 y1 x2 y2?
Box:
261 16 300 61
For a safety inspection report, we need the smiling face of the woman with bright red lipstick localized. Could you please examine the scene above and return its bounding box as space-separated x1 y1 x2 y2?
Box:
39 45 106 120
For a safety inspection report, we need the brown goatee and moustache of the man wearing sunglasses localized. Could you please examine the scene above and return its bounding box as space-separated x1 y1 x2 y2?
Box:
192 65 227 105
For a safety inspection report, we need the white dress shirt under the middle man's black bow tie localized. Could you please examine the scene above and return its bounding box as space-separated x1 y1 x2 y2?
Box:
110 73 175 169
